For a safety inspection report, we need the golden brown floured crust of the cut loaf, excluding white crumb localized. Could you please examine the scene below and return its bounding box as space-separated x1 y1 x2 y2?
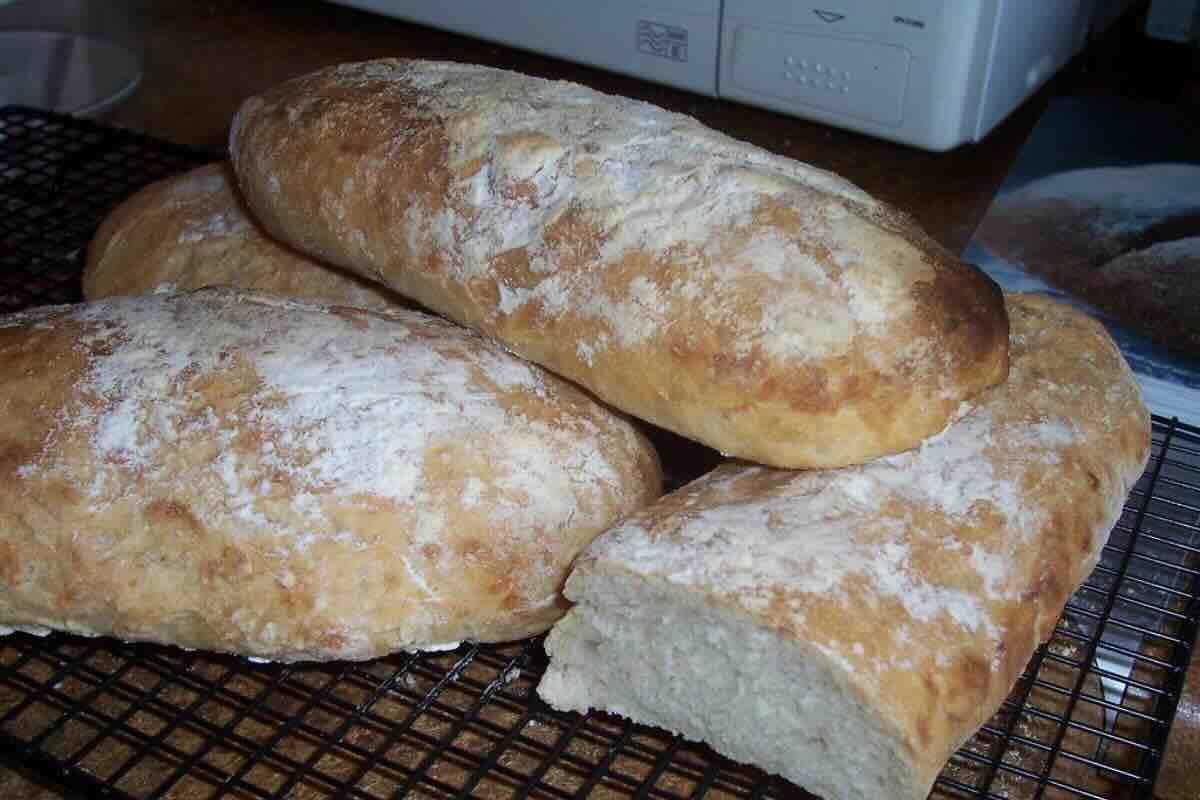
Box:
551 295 1150 798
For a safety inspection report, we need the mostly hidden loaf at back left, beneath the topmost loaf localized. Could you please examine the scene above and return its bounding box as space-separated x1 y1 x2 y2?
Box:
83 163 412 308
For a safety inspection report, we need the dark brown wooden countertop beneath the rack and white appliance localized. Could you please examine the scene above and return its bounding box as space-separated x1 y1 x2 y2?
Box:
0 0 1200 799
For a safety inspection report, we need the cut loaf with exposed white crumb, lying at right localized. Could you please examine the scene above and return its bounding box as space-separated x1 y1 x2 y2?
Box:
538 295 1150 800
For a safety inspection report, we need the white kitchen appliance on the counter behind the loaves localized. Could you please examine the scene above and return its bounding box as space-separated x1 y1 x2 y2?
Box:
334 0 1111 150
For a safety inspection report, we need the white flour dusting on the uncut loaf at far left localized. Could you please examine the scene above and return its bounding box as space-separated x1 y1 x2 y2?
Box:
20 289 632 566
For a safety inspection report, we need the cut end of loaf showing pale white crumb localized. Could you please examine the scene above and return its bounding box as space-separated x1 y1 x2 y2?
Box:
538 567 934 800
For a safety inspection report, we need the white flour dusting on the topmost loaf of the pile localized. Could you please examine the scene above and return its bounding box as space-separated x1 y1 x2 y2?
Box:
260 61 928 366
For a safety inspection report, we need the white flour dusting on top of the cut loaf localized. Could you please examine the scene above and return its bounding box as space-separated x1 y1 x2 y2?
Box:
592 316 1103 656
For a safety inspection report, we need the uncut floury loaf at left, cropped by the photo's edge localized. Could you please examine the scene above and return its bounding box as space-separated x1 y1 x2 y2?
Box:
0 288 659 661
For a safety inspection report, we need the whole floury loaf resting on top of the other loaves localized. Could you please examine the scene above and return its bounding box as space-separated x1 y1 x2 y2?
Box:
230 60 1008 467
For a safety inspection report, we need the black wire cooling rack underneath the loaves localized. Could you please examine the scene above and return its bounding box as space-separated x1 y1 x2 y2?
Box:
0 108 1200 800
